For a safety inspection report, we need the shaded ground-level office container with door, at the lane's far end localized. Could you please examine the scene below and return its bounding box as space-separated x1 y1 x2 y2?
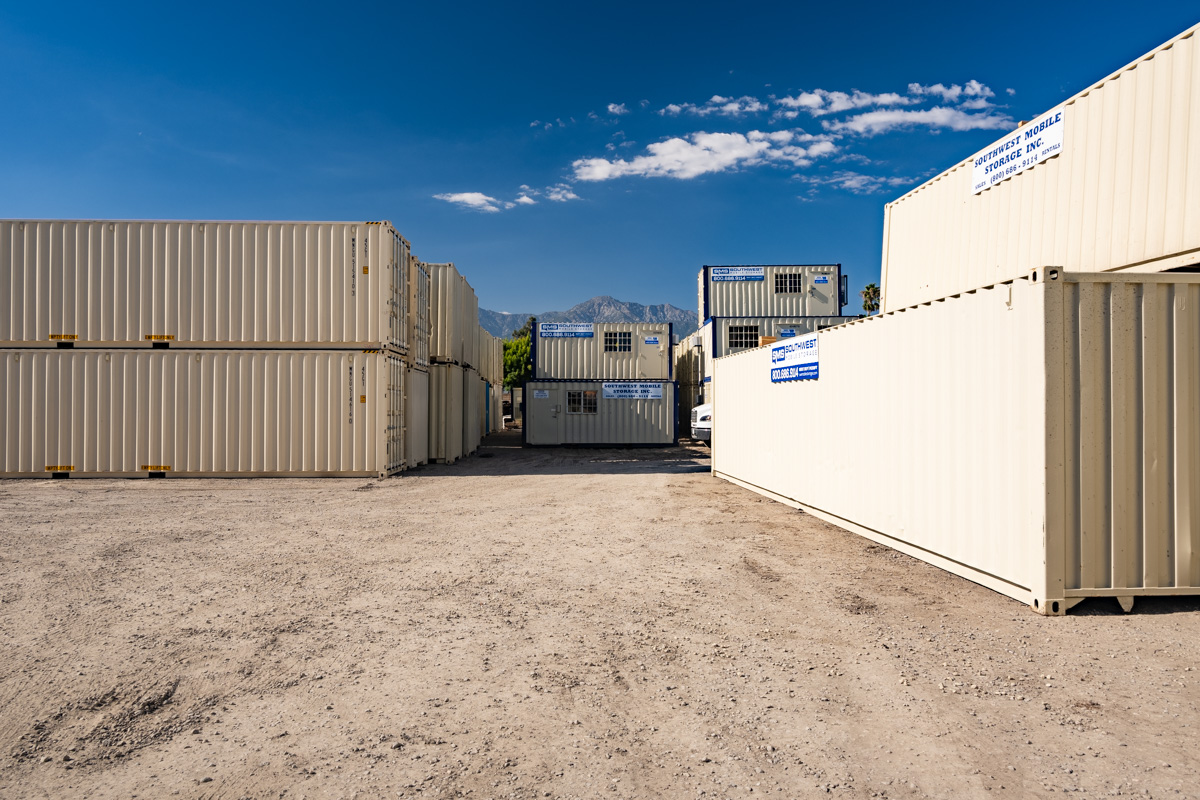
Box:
523 380 678 446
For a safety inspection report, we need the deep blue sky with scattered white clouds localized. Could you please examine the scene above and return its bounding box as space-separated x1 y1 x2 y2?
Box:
0 1 1200 312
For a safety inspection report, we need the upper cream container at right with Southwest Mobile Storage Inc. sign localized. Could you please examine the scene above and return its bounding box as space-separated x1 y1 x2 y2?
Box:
882 26 1200 311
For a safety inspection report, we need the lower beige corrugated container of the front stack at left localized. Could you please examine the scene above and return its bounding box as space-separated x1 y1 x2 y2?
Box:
0 349 404 477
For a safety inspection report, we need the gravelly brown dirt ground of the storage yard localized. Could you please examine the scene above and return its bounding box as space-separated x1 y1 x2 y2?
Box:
0 438 1200 800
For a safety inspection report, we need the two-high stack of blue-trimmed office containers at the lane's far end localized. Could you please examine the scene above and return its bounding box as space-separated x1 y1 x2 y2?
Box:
522 320 679 446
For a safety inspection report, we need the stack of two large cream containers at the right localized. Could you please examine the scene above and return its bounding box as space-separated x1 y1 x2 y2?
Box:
713 25 1200 614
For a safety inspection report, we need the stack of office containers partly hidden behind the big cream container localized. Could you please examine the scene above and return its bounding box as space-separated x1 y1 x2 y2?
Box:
673 264 857 429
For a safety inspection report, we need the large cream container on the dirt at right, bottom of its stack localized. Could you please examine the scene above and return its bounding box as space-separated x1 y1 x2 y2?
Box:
713 270 1200 614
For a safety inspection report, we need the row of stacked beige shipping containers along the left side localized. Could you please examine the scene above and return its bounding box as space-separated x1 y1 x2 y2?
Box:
0 221 503 477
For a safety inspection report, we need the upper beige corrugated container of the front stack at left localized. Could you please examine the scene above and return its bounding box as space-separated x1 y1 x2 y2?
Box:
0 221 408 350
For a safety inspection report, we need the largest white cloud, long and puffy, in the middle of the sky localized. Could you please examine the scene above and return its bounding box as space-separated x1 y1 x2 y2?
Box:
571 131 838 181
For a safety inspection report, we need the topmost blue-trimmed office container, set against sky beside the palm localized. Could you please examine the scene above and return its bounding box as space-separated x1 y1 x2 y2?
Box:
701 264 841 324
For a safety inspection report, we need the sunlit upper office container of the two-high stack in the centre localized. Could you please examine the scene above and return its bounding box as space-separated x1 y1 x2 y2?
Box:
533 323 672 380
